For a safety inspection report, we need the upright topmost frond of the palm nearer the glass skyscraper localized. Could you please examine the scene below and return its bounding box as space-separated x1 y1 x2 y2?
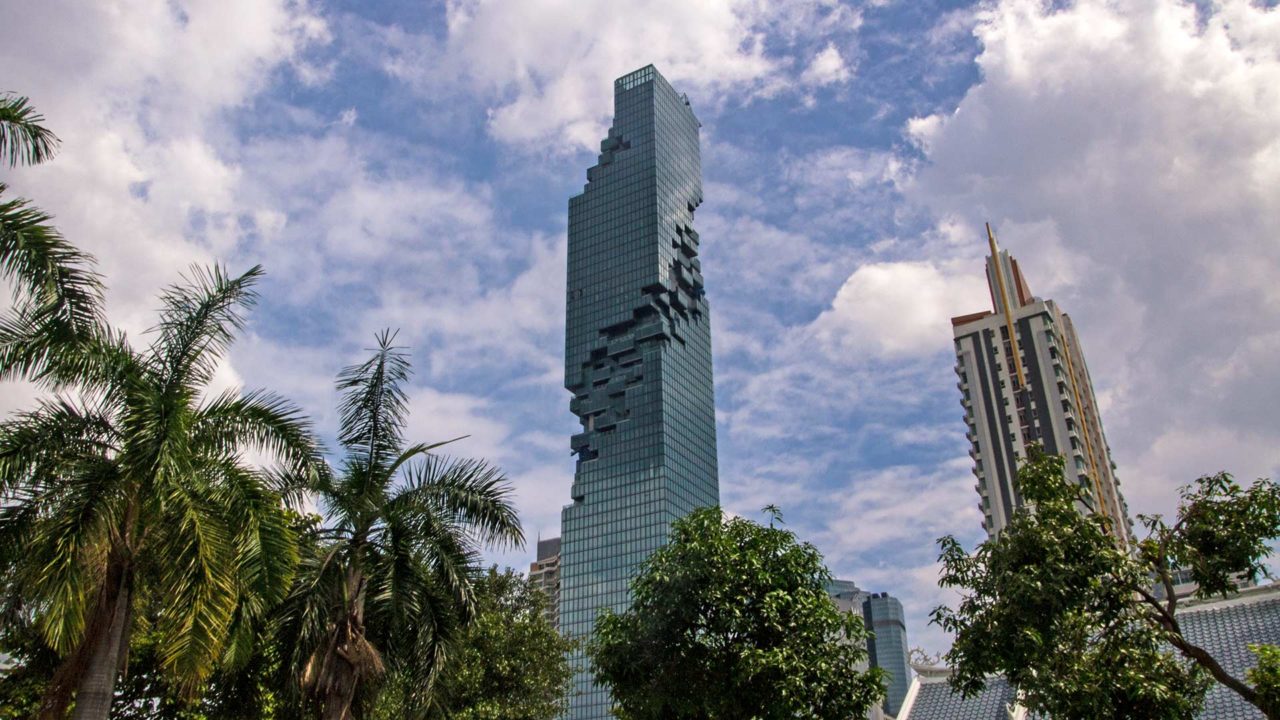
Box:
338 331 410 482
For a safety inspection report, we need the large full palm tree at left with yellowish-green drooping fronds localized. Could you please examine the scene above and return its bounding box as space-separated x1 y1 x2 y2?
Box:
0 268 321 719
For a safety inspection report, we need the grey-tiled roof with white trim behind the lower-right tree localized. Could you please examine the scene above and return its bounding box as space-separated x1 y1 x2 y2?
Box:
897 584 1280 720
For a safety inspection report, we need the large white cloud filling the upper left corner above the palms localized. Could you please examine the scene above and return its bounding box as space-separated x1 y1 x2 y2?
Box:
0 0 326 334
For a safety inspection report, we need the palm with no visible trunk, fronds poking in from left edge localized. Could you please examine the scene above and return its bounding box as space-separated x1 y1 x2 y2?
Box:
0 94 102 382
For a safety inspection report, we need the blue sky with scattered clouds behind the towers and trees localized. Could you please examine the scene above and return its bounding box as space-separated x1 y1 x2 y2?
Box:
0 0 1280 652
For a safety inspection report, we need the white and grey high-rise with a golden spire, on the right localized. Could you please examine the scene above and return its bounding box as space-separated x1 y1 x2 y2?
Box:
951 225 1133 546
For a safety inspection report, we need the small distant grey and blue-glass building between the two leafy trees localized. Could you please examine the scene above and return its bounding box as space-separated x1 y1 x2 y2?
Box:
827 580 911 715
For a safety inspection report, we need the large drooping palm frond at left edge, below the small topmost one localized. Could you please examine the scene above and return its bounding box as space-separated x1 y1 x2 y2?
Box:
0 183 102 334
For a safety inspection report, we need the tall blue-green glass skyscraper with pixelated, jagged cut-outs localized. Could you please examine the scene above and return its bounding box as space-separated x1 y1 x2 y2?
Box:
559 65 719 720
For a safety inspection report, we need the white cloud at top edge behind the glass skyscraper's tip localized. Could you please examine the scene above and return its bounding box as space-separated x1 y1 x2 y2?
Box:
375 0 861 151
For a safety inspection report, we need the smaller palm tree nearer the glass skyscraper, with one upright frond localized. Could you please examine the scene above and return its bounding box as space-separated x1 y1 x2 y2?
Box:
283 332 524 720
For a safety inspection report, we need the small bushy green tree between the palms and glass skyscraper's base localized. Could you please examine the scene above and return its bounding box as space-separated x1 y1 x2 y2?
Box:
422 568 573 720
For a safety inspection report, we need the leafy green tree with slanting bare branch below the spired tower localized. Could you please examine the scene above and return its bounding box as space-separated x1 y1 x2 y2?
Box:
933 450 1280 719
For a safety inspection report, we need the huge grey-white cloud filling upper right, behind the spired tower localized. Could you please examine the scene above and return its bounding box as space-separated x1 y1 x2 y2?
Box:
896 0 1280 511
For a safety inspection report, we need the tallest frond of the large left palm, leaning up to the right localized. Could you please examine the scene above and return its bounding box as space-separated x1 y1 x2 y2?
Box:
150 265 264 388
